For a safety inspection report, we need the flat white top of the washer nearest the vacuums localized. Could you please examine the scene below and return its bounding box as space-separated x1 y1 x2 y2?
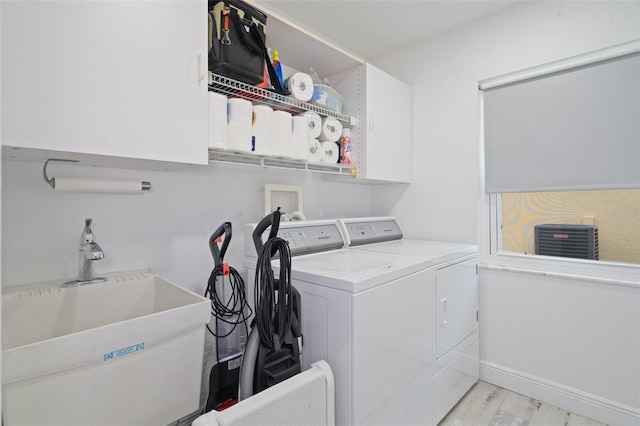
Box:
284 249 429 293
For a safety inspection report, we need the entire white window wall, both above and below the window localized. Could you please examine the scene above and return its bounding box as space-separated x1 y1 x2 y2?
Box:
372 1 640 425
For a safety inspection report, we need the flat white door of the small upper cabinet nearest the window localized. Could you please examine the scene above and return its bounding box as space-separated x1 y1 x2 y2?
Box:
362 64 411 182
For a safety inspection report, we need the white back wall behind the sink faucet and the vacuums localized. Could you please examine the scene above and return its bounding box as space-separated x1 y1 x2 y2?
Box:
2 160 370 294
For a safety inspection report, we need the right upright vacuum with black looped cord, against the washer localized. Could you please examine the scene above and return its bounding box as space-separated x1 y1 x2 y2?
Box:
238 208 302 400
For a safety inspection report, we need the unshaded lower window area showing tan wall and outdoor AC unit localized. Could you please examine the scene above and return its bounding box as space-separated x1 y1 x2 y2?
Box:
496 189 640 264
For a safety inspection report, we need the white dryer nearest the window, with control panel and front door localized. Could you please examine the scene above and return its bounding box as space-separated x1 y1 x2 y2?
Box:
338 217 480 425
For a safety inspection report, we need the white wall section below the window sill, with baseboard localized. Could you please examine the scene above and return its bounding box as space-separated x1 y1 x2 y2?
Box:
480 270 640 425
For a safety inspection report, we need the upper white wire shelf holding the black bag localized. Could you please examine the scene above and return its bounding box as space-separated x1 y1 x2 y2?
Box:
209 73 358 126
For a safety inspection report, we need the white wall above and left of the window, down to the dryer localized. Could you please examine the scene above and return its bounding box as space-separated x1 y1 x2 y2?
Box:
372 1 640 245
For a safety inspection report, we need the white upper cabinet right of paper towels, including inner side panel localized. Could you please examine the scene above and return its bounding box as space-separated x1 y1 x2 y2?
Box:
333 63 411 183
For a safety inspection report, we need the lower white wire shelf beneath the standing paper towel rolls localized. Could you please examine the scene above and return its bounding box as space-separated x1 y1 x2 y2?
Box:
209 148 356 177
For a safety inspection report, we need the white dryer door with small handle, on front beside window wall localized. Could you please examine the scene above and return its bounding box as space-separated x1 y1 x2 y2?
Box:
435 258 478 359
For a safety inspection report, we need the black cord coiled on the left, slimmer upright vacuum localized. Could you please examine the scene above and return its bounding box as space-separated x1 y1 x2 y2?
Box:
204 265 253 338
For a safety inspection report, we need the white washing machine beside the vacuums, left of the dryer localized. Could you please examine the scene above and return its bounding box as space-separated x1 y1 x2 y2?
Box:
244 220 433 425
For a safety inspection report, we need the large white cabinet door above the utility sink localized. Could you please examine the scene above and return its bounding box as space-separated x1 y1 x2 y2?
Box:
2 0 207 164
